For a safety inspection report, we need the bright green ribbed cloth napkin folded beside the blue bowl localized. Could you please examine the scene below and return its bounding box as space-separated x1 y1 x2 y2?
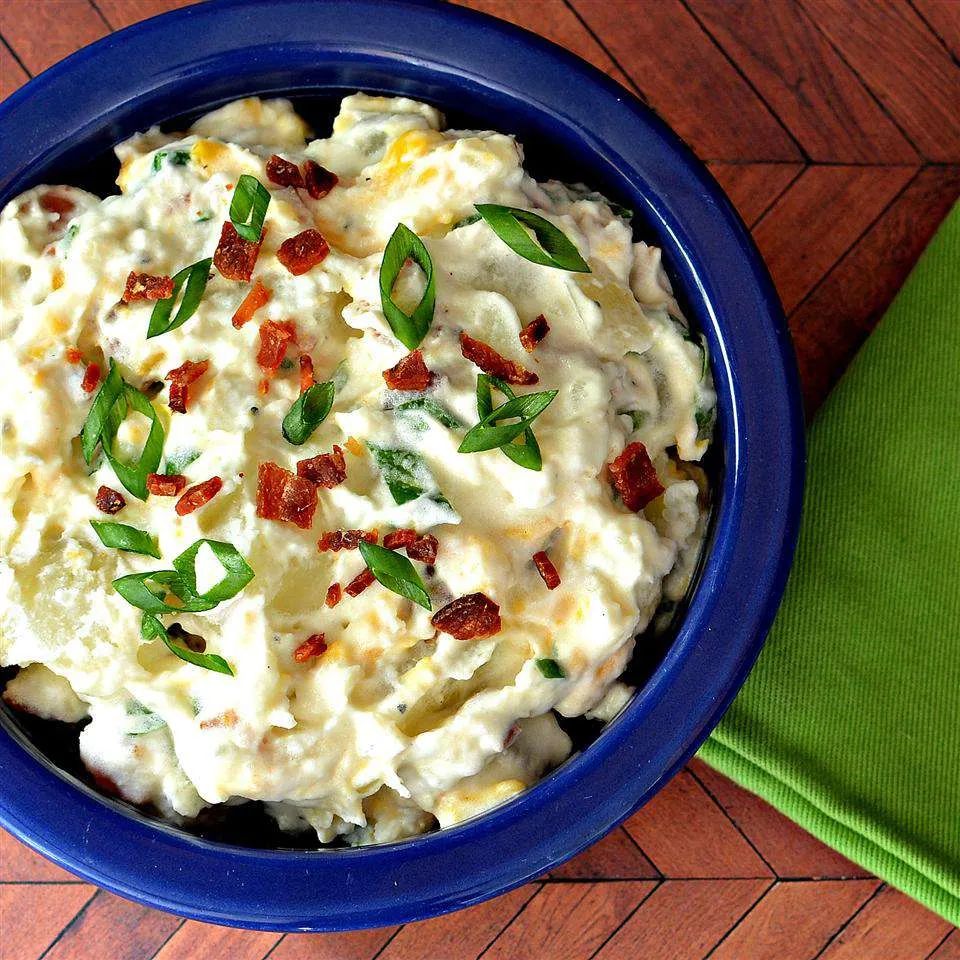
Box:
701 206 960 924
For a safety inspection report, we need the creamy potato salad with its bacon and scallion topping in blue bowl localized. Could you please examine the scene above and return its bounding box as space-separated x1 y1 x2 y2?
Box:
0 94 716 844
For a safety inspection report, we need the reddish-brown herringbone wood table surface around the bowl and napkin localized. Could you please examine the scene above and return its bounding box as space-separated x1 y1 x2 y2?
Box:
0 0 960 960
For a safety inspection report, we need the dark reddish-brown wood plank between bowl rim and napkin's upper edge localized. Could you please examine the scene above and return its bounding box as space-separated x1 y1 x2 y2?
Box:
788 167 960 416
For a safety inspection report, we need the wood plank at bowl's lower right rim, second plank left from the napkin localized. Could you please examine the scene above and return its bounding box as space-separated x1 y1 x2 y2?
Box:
624 770 773 877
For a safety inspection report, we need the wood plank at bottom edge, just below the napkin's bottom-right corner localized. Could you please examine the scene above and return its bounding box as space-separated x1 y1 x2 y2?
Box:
822 887 951 960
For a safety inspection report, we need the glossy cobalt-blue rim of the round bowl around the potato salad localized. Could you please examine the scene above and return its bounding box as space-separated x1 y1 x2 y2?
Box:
0 0 804 931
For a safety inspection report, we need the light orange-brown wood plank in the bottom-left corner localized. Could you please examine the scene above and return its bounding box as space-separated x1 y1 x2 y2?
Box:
0 883 97 960
